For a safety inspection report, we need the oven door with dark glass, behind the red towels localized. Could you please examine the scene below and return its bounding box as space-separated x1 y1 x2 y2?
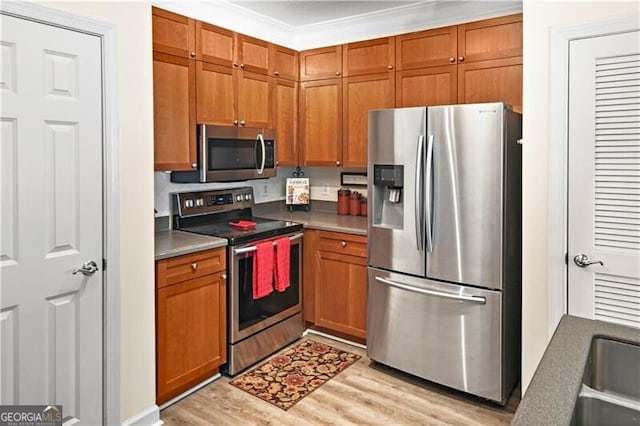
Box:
228 232 303 344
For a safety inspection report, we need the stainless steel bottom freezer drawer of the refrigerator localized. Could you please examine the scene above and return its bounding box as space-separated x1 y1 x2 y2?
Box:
367 268 511 404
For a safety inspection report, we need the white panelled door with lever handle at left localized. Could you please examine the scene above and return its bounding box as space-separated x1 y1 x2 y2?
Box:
0 15 103 424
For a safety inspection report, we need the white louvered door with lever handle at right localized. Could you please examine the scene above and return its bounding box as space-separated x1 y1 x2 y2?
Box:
568 31 640 327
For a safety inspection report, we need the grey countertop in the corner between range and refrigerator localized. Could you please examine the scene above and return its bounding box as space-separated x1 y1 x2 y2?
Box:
253 202 367 235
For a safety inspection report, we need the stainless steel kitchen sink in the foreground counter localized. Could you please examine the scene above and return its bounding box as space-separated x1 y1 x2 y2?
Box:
571 337 640 426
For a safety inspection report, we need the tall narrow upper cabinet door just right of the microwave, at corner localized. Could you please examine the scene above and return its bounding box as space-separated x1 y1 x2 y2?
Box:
271 78 300 166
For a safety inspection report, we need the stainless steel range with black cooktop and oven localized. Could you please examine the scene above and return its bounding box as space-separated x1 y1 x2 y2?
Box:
171 187 304 375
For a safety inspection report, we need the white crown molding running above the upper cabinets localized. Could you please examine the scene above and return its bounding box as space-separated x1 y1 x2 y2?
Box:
153 0 522 50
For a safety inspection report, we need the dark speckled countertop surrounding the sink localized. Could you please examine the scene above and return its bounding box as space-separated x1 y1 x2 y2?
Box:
512 315 640 425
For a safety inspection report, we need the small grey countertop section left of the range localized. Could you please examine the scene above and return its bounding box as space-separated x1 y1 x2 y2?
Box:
155 230 227 260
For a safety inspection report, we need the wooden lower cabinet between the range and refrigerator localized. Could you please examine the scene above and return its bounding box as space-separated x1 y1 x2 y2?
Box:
305 231 367 340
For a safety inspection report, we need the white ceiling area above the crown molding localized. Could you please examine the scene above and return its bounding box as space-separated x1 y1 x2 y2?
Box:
229 0 425 27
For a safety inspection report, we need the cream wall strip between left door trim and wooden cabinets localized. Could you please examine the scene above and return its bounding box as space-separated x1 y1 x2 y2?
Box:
36 1 155 420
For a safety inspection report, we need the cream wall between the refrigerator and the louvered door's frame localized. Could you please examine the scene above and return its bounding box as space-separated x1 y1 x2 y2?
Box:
522 0 640 391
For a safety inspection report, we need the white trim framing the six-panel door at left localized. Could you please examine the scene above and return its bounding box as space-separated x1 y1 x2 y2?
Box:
0 1 120 424
